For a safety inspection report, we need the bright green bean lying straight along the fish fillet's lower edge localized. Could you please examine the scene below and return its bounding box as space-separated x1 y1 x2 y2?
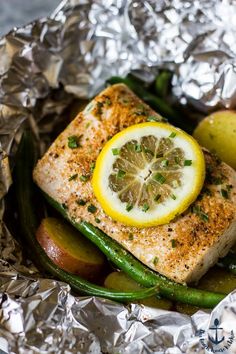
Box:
44 194 225 308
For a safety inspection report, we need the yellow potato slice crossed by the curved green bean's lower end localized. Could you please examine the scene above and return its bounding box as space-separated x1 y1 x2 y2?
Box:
104 272 172 310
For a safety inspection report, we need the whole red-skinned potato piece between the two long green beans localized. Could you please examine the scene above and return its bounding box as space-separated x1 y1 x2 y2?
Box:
36 217 105 281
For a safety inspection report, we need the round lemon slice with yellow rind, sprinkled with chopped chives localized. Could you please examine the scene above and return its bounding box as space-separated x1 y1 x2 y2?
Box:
92 123 205 227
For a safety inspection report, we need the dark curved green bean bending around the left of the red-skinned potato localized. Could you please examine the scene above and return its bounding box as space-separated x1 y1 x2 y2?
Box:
14 133 158 302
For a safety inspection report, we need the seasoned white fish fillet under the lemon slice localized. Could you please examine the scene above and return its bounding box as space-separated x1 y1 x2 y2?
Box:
34 84 236 283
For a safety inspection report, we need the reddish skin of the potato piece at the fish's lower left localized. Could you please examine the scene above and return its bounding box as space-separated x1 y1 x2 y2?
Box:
36 223 105 283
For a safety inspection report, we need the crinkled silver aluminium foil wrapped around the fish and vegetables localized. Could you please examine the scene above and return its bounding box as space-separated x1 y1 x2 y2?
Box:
0 0 236 354
